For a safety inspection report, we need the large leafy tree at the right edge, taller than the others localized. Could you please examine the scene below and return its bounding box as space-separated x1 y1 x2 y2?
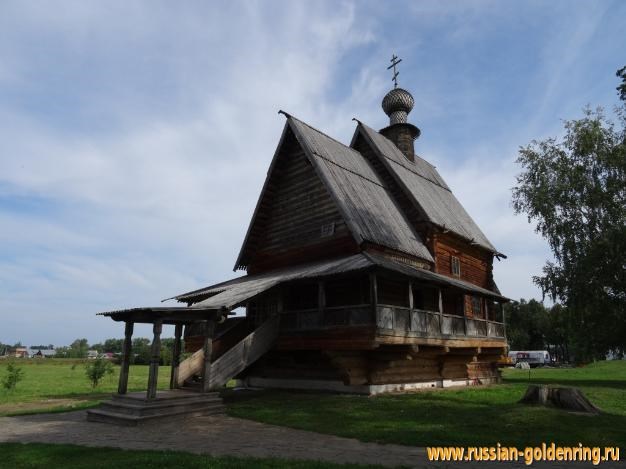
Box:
513 71 626 360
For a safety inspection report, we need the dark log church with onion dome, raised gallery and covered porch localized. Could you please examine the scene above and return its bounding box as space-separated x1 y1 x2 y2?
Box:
89 60 508 422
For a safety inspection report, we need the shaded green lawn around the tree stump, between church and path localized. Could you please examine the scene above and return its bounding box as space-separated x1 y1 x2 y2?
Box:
226 362 626 448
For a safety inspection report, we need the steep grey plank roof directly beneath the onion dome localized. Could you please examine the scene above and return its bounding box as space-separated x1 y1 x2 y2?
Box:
352 122 498 254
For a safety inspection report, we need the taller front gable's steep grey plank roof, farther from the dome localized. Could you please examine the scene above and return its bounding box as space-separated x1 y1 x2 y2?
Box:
235 113 433 269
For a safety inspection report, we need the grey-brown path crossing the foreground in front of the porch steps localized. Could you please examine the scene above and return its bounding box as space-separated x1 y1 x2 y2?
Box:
0 411 624 469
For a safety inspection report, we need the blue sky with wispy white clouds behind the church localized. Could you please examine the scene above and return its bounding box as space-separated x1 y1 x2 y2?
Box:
0 0 626 345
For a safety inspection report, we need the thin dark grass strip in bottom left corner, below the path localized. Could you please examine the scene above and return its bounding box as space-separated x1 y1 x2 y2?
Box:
0 443 375 469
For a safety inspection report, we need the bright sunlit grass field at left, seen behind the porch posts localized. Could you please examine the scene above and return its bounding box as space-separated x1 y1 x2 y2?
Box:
0 358 170 415
